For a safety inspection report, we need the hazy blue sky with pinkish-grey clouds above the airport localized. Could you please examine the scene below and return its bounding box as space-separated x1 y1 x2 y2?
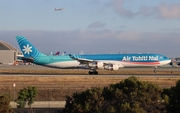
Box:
0 0 180 57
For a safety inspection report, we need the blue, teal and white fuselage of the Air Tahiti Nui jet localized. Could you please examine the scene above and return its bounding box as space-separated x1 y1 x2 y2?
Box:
33 54 170 68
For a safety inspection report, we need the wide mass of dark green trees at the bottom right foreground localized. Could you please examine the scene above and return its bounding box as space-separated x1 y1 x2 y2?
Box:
63 76 180 113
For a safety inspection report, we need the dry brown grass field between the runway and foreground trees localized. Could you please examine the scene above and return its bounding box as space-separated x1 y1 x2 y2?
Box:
0 75 180 100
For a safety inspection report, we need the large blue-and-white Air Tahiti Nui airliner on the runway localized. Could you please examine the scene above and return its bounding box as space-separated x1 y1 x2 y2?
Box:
16 36 171 74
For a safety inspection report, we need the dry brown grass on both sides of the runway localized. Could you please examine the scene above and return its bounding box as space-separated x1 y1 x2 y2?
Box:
0 67 180 100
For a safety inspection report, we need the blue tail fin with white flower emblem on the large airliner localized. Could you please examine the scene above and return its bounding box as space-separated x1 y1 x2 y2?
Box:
16 36 46 60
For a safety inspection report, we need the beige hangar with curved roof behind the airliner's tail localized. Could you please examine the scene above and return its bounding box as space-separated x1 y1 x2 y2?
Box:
0 40 21 65
